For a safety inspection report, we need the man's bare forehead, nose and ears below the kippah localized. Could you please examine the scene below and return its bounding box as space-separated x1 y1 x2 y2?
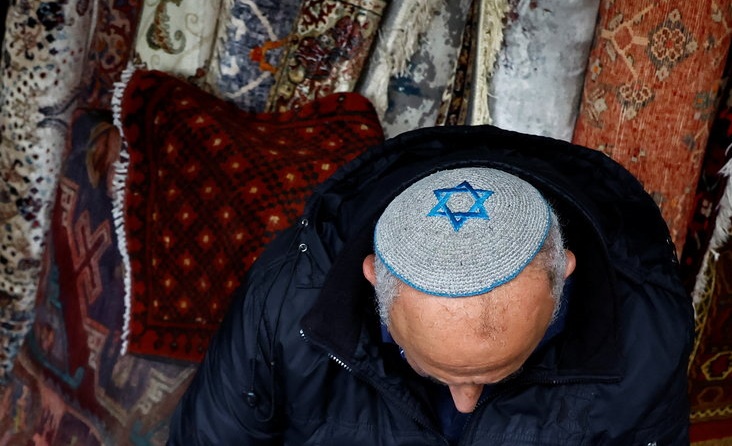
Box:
363 246 575 412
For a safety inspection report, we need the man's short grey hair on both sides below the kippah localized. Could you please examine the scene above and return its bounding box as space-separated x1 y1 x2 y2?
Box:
374 211 567 327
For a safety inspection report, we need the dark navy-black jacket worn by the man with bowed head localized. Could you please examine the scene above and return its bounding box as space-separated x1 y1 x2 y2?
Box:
170 126 693 446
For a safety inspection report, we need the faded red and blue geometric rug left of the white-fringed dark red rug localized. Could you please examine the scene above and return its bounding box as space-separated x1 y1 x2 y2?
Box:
0 109 195 446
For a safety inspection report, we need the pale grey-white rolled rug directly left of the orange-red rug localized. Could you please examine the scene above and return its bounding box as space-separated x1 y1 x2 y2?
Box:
485 0 600 141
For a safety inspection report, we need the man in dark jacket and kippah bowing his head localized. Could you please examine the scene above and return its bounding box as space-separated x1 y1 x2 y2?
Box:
170 126 693 445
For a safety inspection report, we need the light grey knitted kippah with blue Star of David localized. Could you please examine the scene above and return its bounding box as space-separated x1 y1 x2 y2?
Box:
374 167 551 297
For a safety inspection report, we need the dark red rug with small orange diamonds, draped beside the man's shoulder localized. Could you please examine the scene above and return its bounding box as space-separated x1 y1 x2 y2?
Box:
118 71 383 361
